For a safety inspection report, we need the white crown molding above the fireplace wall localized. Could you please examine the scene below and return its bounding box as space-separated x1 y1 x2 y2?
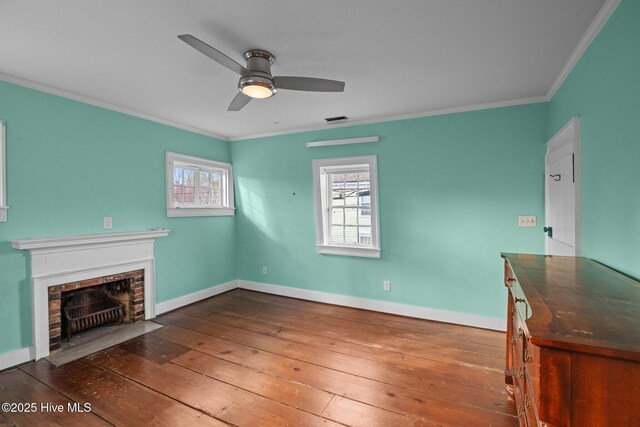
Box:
0 72 229 141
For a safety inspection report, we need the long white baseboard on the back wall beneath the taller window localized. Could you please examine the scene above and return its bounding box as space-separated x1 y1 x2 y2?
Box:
237 280 507 331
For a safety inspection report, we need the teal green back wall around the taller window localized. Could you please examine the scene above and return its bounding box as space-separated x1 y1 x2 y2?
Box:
231 104 547 318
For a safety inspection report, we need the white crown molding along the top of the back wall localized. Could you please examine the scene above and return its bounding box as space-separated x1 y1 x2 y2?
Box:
228 96 548 142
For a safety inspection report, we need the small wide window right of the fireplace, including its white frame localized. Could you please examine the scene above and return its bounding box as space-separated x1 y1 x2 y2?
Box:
165 151 234 217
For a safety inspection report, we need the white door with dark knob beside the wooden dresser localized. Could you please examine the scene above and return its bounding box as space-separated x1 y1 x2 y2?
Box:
544 117 580 256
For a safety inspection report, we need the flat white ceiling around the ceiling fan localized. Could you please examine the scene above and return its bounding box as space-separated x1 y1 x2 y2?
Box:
0 0 605 139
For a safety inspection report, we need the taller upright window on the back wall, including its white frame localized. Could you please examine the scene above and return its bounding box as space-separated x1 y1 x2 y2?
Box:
313 156 380 258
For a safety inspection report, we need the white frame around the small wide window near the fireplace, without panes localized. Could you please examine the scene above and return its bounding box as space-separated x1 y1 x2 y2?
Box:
165 151 235 217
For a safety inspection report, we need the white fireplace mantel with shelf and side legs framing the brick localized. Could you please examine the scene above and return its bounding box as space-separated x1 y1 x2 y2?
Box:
11 229 170 360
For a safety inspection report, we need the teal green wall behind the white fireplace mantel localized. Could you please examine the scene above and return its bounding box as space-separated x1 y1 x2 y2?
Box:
0 82 236 353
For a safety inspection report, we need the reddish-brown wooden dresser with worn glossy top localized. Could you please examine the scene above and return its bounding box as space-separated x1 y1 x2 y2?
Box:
502 253 640 427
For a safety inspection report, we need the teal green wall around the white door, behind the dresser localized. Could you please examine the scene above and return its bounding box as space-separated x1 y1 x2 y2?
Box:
548 0 640 277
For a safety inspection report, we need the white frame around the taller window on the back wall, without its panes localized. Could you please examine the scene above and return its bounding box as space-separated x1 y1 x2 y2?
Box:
312 155 381 258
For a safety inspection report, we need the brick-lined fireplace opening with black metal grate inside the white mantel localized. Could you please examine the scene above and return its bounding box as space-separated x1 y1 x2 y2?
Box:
49 270 144 352
